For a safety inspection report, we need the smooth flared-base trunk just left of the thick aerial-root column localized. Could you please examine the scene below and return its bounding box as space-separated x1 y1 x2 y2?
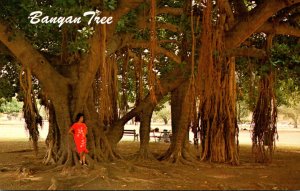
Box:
159 81 194 164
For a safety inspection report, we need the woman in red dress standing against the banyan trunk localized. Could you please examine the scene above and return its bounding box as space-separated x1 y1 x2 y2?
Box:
69 113 89 165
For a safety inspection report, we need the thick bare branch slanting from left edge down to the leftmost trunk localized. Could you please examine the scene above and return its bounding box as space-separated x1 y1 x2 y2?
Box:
0 21 69 100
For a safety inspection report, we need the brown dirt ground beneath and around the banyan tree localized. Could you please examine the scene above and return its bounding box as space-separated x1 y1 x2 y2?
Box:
0 141 300 190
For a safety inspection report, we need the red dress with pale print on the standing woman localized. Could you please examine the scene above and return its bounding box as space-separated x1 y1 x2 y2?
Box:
71 123 89 153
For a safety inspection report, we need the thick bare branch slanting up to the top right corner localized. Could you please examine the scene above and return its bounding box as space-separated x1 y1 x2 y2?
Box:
225 0 300 49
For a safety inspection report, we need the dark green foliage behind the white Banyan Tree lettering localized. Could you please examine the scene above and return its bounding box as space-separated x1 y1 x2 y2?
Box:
0 0 95 55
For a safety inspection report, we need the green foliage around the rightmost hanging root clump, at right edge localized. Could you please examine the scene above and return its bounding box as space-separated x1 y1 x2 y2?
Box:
236 35 300 110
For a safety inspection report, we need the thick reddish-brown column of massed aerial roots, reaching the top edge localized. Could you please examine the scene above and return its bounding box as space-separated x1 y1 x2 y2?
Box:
198 1 239 164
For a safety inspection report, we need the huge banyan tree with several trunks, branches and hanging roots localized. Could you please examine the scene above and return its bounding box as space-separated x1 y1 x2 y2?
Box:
0 0 300 165
